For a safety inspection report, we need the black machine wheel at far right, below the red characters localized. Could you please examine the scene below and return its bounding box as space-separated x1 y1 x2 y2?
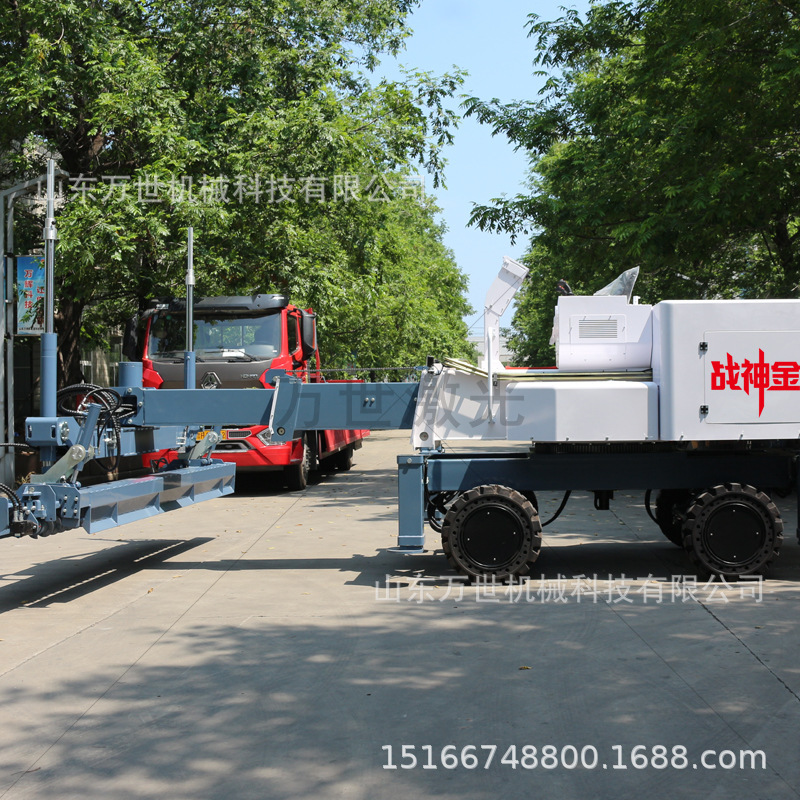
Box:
683 483 783 578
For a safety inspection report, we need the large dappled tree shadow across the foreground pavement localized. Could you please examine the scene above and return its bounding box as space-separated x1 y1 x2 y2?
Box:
0 588 800 800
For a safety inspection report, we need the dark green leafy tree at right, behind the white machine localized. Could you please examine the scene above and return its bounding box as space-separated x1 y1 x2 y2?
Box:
467 0 800 359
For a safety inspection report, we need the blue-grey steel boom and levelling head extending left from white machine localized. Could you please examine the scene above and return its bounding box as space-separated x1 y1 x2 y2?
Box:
7 376 419 537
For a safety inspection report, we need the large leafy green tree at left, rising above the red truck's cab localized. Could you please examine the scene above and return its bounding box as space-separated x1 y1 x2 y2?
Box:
0 0 476 380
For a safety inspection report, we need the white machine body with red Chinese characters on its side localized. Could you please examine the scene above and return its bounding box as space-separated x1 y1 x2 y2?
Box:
412 266 800 448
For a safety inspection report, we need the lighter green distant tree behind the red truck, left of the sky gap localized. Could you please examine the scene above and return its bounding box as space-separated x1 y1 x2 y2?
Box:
299 198 474 377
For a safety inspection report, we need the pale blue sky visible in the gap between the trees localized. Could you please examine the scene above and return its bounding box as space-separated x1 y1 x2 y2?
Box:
379 0 589 332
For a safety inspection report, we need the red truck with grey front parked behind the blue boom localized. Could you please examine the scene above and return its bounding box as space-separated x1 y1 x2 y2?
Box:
142 294 369 490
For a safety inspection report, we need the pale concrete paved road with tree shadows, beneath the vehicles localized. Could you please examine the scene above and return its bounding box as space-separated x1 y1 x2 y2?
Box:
0 434 800 800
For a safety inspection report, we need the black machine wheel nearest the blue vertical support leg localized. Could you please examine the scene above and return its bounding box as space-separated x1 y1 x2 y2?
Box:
442 484 542 580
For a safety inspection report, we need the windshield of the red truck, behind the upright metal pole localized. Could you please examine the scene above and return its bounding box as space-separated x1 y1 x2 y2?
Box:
147 311 281 360
